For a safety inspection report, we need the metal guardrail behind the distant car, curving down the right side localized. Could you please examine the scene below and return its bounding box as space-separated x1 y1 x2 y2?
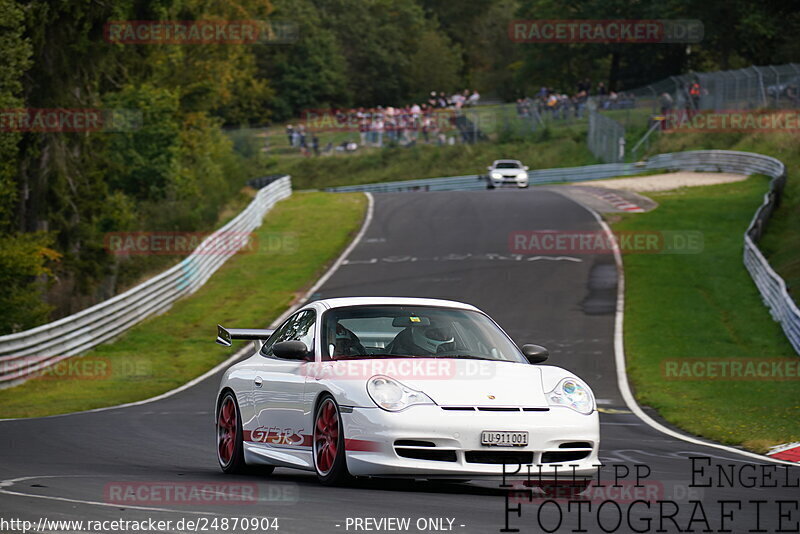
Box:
327 150 800 354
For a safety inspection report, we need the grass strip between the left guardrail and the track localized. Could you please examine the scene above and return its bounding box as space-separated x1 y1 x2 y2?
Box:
0 193 366 418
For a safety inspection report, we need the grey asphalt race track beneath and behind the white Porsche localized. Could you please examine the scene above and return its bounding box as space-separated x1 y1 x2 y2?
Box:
0 189 800 533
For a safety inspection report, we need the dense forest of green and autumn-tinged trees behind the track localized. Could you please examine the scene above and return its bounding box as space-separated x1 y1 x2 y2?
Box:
0 0 800 334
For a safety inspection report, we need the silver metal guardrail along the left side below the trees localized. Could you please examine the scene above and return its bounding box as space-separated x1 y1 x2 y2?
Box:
0 176 292 388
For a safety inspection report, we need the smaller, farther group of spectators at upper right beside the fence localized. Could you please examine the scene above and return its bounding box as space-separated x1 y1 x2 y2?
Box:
517 78 636 119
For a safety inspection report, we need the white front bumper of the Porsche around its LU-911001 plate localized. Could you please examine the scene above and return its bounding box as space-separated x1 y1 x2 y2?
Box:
342 406 600 480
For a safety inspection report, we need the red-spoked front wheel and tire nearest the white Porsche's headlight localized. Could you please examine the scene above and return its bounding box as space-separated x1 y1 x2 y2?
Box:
312 395 352 486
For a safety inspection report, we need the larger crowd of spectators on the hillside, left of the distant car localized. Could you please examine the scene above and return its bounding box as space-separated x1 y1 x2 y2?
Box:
286 89 480 155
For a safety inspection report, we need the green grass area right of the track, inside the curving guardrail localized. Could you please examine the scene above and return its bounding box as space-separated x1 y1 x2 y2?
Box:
614 176 800 452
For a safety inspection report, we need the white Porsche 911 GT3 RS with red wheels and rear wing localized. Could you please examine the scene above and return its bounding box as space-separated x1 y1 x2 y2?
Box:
215 297 599 489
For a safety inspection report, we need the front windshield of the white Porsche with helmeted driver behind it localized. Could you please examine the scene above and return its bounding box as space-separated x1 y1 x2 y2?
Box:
322 306 525 363
